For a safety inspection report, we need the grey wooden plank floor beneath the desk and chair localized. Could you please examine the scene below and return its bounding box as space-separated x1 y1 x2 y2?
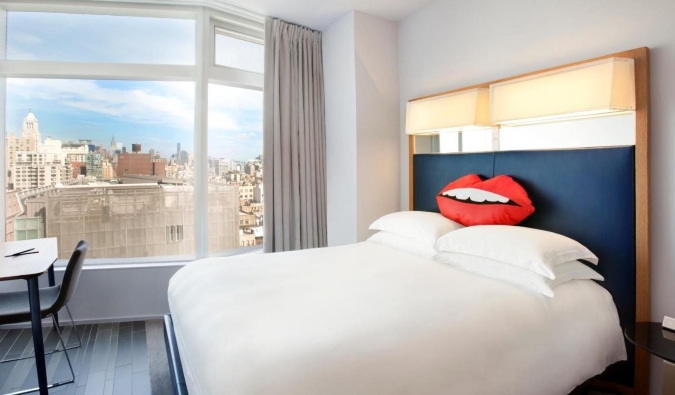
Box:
0 321 151 395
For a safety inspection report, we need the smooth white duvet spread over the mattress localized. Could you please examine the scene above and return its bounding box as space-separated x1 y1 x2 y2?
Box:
168 242 626 395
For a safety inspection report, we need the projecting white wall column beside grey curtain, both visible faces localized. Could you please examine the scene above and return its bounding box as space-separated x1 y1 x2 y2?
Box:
323 11 399 246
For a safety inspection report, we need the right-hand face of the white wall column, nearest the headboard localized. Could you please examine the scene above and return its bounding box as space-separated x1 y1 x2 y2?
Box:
354 12 400 241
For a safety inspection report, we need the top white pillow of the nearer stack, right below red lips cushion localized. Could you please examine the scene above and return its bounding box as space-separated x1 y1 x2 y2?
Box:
436 225 598 279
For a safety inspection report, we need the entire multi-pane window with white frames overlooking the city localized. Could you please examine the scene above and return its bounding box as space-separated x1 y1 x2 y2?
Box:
0 2 264 264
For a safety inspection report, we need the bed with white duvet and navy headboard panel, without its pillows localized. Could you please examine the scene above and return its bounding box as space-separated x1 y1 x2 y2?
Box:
166 147 636 395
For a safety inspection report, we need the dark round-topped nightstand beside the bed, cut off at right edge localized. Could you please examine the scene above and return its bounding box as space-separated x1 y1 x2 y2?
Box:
623 322 675 395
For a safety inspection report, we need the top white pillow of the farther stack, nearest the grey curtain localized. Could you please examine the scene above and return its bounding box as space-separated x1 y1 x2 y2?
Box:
369 211 464 247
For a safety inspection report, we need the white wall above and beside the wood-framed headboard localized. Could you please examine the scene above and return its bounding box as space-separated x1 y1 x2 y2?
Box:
399 0 675 393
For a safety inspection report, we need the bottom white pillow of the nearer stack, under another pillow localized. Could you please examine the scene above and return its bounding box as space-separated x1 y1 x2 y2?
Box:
434 252 604 298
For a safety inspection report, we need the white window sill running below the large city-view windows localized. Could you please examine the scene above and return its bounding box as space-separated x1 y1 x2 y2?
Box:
54 245 263 271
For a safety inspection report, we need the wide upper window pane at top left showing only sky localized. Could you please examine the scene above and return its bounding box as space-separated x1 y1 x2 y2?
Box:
7 12 195 65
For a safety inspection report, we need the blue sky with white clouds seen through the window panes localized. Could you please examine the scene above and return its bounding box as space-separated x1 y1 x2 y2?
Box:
6 12 263 160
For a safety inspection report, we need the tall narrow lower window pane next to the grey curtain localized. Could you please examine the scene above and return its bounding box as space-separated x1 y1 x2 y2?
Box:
208 66 263 252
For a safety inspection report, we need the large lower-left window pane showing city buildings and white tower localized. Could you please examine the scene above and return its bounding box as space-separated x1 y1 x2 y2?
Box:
6 78 195 258
